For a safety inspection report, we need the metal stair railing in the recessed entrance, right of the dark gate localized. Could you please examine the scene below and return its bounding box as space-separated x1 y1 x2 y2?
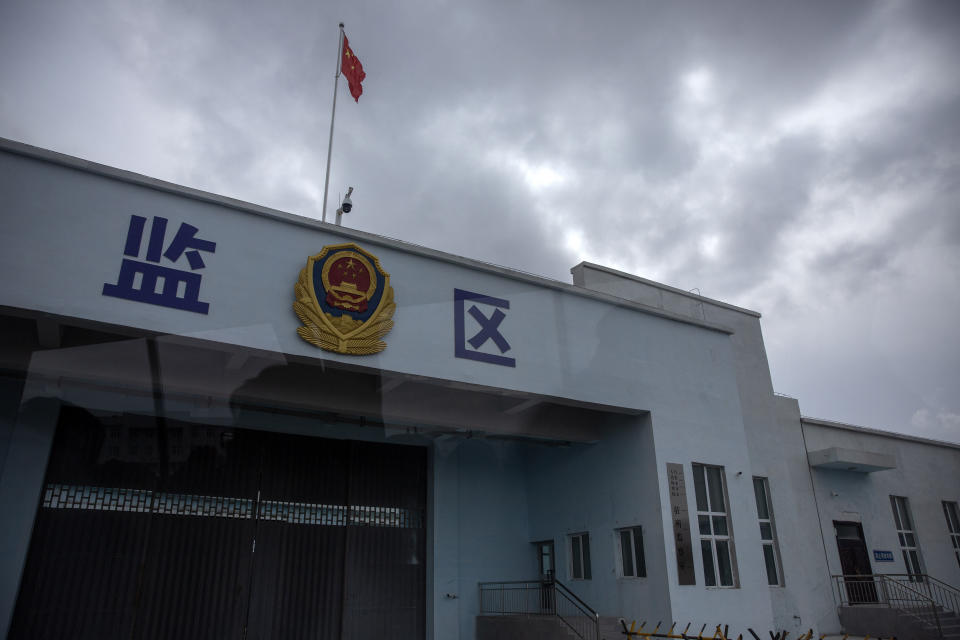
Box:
479 580 600 640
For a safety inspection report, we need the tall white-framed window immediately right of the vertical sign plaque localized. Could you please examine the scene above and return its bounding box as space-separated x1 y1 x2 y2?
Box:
693 464 737 587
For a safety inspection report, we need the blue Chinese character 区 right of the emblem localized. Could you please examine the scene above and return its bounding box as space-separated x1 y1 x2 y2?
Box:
453 289 517 367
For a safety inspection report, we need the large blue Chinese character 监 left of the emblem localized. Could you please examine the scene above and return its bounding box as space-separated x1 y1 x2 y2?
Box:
103 215 217 314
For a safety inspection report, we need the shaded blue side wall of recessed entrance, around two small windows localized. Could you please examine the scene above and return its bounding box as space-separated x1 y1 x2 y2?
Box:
527 415 673 620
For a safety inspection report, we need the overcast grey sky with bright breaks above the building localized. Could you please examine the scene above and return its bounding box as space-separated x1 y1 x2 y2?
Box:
0 0 960 441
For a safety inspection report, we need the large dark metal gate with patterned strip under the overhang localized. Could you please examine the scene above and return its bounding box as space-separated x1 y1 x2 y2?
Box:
9 408 426 640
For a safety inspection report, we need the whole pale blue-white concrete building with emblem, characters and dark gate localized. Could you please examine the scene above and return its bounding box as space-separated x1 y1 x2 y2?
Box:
0 141 960 640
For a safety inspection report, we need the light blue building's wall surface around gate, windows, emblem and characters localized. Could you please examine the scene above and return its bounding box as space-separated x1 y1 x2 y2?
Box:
0 141 960 640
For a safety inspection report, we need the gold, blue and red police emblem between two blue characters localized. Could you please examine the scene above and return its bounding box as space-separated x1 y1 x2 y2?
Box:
293 242 397 355
